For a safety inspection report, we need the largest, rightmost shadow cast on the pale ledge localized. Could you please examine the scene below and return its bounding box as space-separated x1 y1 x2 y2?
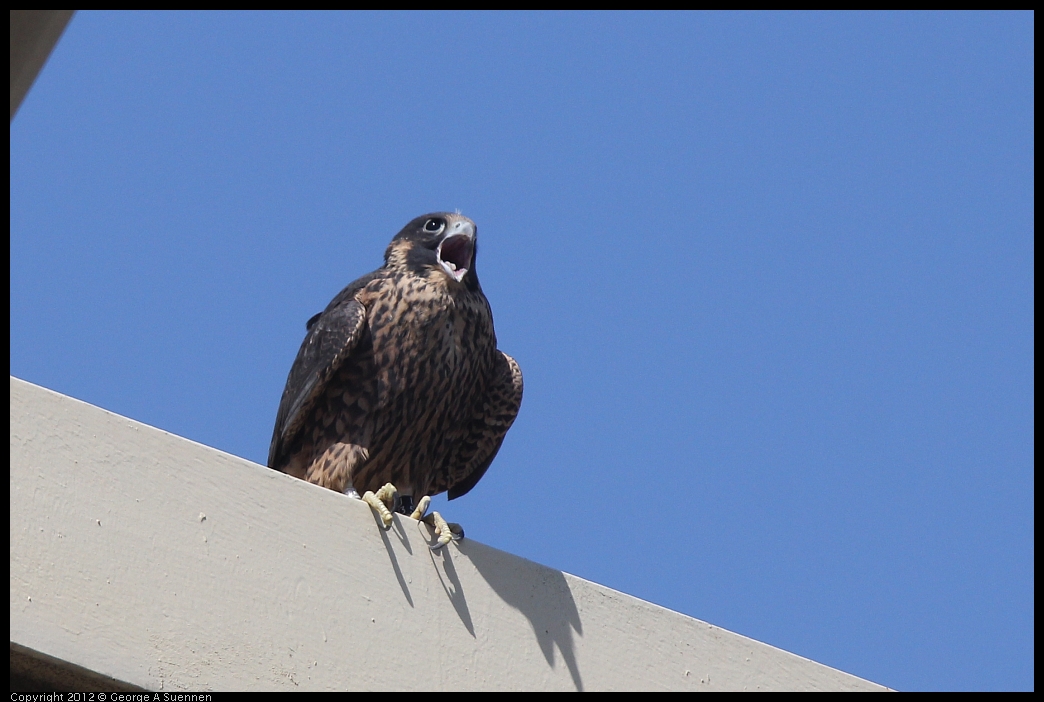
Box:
467 539 584 692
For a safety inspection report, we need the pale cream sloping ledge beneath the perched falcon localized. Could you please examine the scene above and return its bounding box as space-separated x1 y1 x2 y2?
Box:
10 378 884 692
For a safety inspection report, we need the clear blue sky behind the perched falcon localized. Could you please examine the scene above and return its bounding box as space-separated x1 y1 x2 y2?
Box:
10 13 1034 689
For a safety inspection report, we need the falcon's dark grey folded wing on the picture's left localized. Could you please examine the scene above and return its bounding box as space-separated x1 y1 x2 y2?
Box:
268 296 366 468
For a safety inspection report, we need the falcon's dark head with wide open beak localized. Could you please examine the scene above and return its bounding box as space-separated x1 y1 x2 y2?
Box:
384 212 478 290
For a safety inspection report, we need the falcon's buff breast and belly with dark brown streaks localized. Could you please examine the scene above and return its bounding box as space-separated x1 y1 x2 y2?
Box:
353 277 497 496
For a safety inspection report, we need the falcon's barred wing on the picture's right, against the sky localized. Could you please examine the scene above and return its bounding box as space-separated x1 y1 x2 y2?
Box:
447 351 522 499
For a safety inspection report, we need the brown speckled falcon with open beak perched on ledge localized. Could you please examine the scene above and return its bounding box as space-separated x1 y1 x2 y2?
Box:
268 212 523 549
